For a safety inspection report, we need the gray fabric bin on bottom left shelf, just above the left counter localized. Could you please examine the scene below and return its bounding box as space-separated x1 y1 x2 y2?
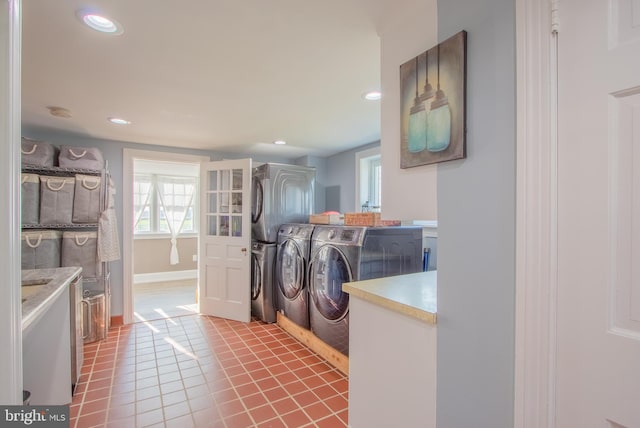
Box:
21 230 62 269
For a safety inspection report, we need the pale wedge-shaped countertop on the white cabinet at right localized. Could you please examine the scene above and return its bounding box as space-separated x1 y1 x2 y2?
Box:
342 271 438 324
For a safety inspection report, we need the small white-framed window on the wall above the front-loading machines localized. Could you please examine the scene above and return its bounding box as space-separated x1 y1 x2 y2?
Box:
356 148 382 212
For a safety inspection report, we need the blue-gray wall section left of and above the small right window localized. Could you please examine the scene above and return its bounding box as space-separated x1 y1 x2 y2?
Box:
323 141 384 213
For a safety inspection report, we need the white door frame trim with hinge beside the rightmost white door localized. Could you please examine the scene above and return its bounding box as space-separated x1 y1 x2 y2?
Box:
514 0 558 428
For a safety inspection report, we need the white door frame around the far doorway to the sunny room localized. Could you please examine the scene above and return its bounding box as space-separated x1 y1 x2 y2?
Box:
122 148 211 324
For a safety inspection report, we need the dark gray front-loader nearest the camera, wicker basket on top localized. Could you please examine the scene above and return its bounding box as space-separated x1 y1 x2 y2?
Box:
308 226 422 355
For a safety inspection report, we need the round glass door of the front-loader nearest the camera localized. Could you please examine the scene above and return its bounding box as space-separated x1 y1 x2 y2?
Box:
309 245 351 321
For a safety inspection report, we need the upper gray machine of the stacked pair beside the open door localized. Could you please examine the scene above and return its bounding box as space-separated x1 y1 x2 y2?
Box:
251 163 316 242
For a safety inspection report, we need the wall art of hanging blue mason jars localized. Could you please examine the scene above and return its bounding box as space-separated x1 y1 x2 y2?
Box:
400 31 467 168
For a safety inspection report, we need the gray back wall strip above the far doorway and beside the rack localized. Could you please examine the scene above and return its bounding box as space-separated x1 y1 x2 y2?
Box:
22 128 293 315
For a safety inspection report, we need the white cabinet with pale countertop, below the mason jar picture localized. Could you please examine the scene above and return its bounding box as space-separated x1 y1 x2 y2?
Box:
343 271 437 428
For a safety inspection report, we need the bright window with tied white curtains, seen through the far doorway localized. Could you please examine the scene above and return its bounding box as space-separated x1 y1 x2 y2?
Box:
133 161 199 236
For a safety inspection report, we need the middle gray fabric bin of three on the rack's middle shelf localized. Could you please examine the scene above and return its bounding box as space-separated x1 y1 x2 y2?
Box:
40 175 75 224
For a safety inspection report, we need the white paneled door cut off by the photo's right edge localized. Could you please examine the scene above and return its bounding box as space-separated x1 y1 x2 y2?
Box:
556 0 640 428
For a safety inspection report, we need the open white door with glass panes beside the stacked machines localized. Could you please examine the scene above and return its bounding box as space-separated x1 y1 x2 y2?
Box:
198 159 251 322
